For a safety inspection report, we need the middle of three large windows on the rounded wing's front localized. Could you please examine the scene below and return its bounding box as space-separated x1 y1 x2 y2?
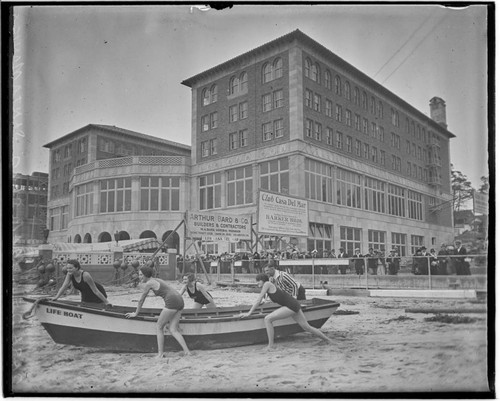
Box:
99 178 132 213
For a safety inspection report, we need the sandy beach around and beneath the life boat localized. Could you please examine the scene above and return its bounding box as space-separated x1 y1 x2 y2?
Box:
12 283 489 396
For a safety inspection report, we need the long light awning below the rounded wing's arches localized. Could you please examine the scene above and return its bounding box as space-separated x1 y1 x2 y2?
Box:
53 238 161 253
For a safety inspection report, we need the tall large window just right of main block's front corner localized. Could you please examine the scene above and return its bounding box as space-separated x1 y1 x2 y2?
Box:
304 159 333 203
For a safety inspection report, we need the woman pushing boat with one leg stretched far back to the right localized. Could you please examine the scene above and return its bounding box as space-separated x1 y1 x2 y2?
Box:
240 273 333 350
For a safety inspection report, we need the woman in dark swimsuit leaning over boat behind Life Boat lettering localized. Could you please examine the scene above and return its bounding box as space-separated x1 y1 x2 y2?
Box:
52 259 111 305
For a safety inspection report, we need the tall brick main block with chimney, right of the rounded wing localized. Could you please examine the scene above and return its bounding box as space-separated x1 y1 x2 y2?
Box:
182 30 454 256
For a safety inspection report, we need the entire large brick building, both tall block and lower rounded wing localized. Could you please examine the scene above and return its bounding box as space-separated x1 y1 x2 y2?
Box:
45 30 454 256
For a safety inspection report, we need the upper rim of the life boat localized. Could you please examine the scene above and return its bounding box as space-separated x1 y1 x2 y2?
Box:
23 297 340 324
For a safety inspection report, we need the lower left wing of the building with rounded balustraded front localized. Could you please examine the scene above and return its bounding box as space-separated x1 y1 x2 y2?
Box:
45 124 191 252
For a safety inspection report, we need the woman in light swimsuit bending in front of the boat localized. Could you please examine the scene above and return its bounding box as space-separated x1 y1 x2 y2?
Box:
125 266 191 358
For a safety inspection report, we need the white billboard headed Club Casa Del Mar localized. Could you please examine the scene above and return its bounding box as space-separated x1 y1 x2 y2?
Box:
257 191 309 237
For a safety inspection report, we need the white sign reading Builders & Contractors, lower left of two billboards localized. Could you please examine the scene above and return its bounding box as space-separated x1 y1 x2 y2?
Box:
186 212 252 242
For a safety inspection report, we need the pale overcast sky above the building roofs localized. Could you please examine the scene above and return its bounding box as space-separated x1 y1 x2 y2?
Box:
12 4 489 188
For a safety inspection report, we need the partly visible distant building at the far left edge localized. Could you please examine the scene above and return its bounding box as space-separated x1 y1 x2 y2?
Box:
12 171 49 245
